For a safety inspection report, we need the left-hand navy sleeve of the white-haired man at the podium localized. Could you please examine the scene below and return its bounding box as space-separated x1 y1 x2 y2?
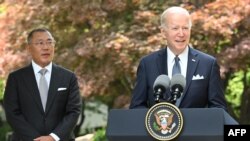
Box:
129 60 148 109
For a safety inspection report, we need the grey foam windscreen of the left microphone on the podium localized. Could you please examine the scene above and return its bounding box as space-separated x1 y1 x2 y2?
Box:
153 74 170 90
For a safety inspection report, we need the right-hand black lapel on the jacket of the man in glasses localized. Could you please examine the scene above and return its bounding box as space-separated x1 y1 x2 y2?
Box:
45 64 60 113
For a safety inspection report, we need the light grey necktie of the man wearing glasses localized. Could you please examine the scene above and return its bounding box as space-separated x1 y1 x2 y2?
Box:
39 69 49 111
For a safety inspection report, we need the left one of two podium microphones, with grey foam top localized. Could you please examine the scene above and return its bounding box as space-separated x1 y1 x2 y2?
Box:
153 74 170 103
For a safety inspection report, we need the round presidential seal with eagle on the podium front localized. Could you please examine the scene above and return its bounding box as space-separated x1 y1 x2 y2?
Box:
145 102 183 141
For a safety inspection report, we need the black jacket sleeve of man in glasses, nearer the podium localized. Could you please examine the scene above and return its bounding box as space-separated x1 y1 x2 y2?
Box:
53 74 82 140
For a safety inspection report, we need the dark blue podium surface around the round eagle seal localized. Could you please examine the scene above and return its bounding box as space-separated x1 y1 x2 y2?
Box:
106 108 238 141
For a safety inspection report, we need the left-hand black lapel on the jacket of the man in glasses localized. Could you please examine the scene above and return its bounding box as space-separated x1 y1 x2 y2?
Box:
23 64 44 112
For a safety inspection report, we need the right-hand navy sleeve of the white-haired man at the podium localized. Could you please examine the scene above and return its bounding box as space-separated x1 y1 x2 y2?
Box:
208 60 227 111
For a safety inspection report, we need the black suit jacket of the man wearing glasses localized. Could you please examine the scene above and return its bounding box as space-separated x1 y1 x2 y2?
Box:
4 64 82 141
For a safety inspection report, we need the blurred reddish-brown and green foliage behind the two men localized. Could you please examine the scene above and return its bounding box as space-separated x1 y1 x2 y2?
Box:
0 0 250 141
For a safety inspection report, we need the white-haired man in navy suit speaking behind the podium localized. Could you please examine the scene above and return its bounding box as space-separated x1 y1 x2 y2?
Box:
130 6 227 110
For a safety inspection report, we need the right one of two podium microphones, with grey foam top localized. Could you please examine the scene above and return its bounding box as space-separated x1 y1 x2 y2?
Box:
169 74 186 104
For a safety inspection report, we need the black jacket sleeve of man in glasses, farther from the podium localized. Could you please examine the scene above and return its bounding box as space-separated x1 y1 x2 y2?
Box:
3 74 40 140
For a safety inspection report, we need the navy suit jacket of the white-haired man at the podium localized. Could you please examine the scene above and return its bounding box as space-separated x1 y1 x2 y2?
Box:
130 48 226 110
